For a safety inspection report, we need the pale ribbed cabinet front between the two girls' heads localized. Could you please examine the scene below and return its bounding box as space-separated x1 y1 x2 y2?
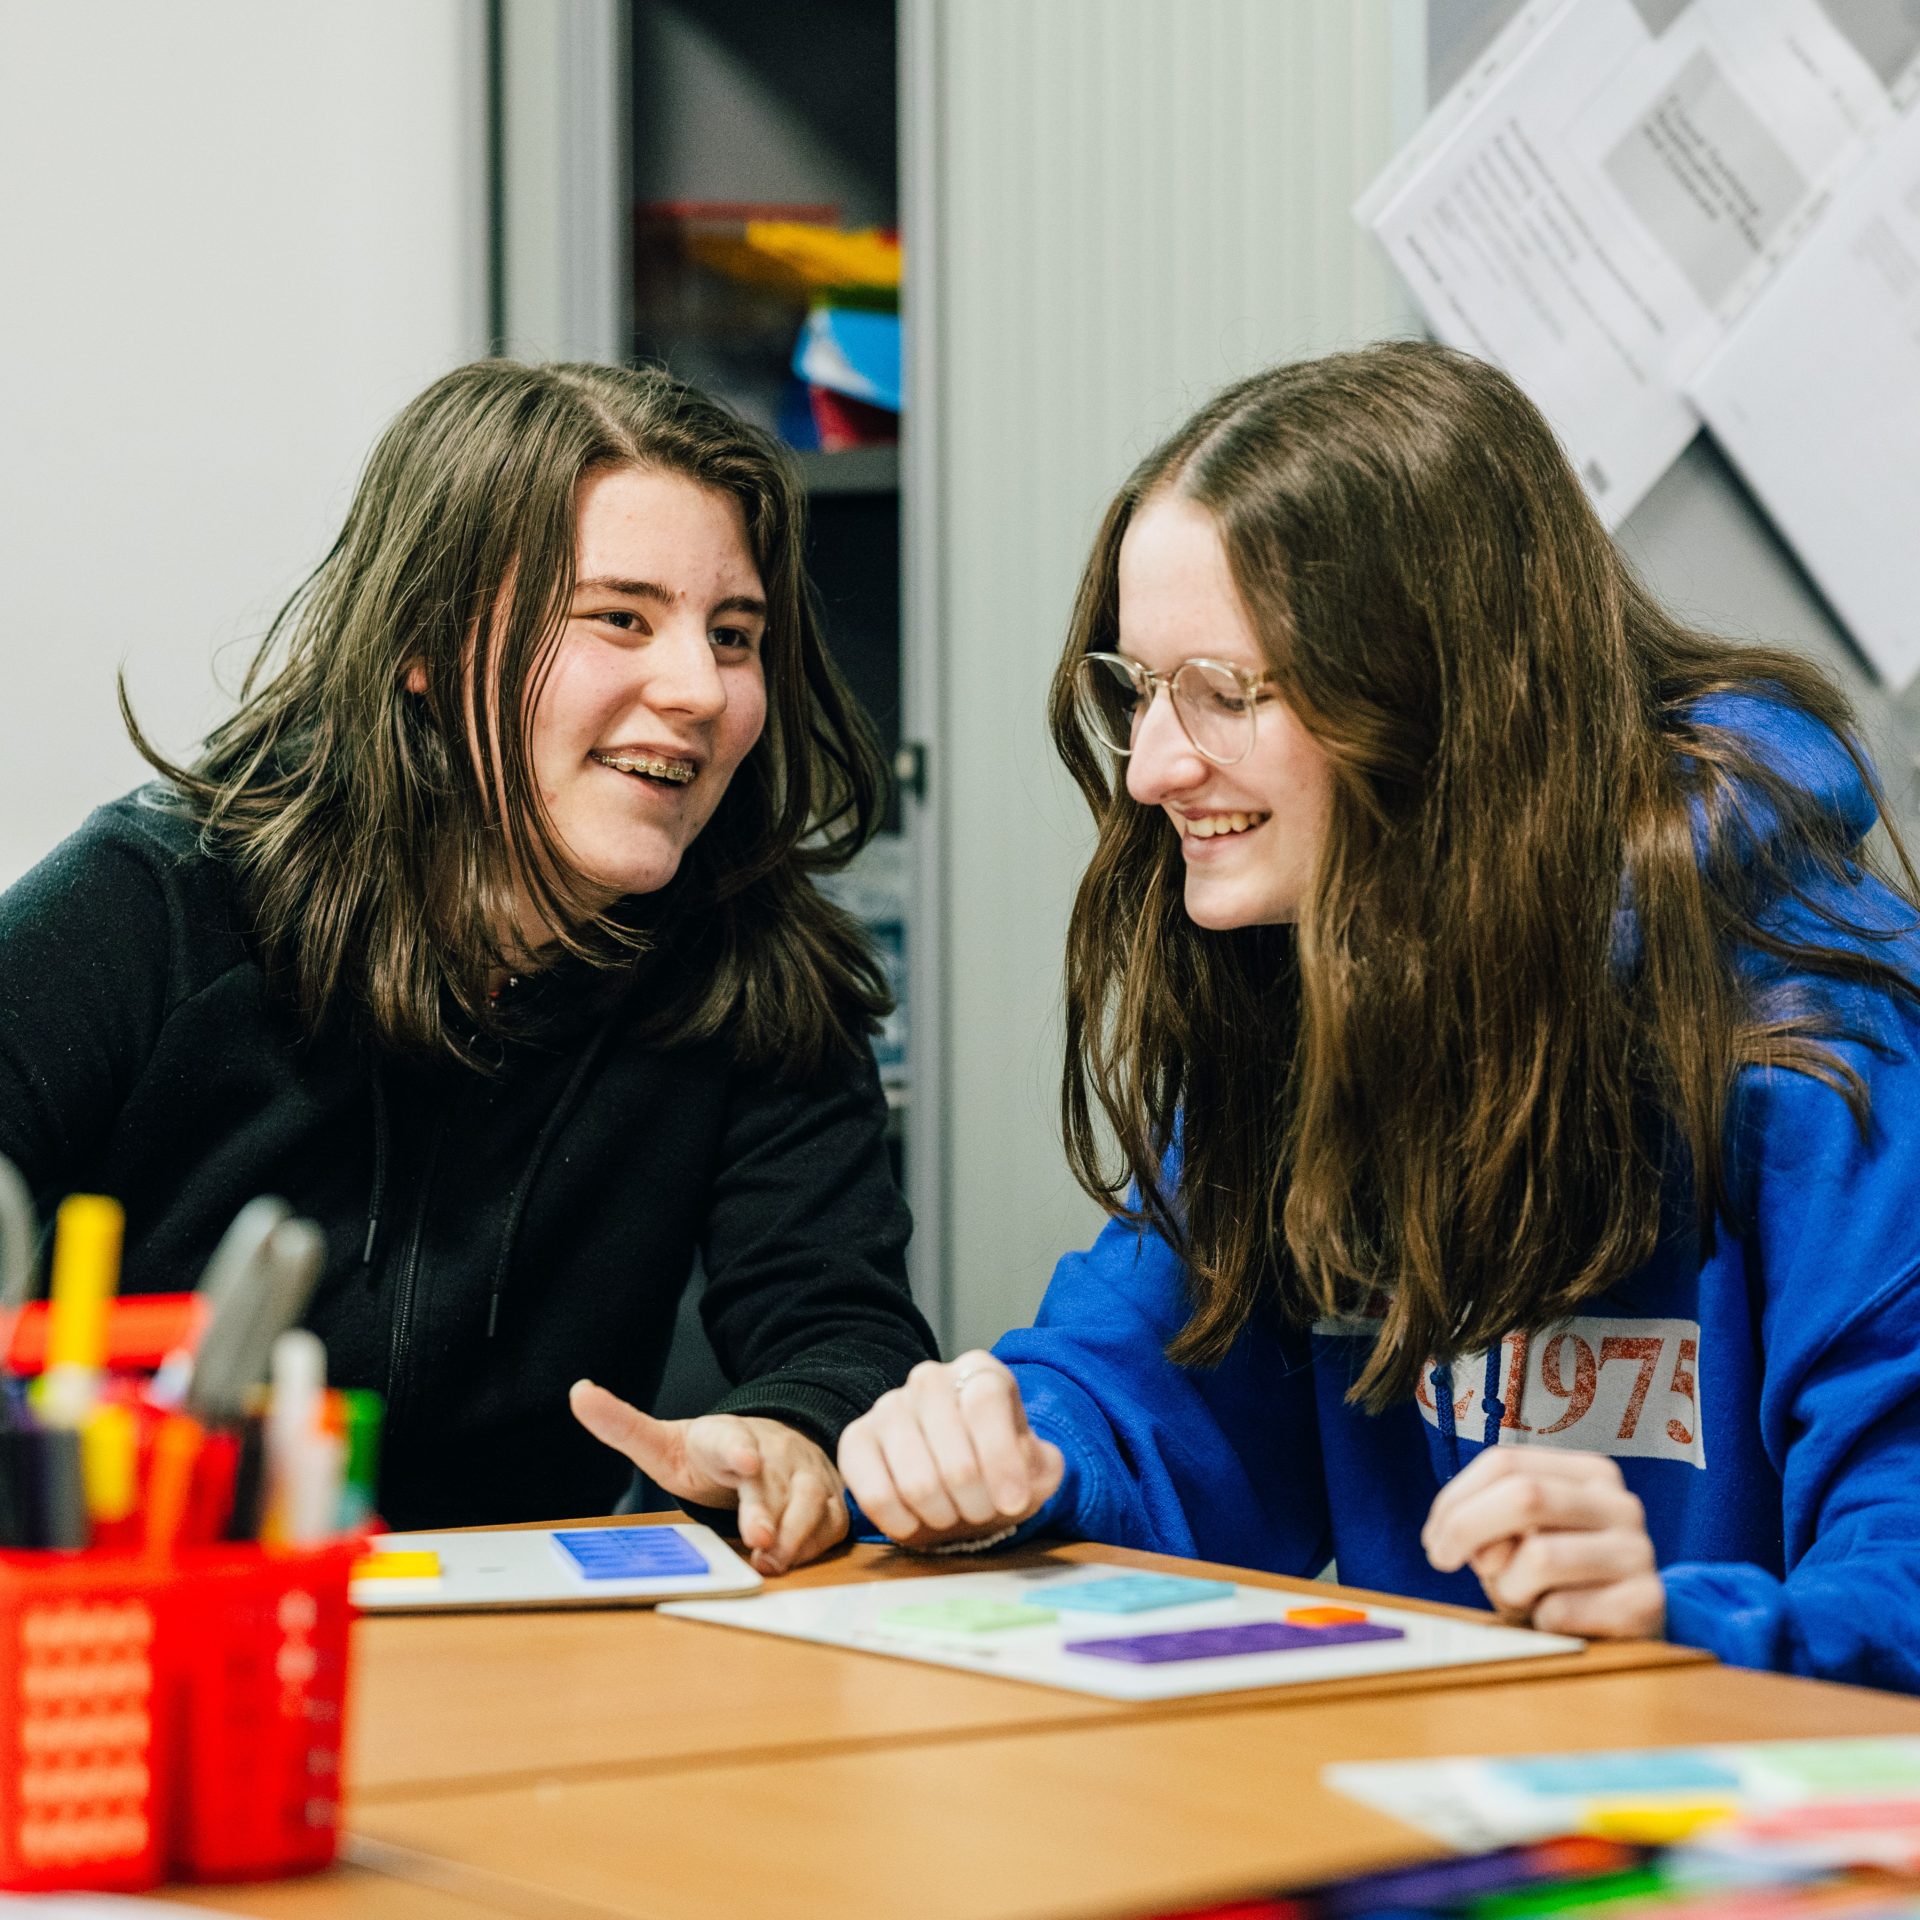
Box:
902 0 1425 1344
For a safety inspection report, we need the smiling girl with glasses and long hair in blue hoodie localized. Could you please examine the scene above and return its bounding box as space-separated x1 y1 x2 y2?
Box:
839 344 1920 1688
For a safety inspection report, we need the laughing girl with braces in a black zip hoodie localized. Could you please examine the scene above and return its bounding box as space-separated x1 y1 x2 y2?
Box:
0 361 933 1571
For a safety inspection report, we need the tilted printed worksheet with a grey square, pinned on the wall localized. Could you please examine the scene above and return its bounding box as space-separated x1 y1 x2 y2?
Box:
1356 0 1920 526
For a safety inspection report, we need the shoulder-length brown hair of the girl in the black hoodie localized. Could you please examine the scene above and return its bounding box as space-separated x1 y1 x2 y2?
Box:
121 361 889 1066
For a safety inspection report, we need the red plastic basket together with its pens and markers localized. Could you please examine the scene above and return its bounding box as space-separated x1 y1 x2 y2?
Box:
0 1162 378 1891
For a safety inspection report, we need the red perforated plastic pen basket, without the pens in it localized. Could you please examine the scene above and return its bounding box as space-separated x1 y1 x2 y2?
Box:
0 1542 361 1891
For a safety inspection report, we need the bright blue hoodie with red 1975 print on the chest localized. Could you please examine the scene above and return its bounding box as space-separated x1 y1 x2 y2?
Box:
995 695 1920 1690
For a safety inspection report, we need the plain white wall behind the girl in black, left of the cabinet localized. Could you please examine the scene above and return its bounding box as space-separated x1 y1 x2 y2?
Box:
0 0 486 885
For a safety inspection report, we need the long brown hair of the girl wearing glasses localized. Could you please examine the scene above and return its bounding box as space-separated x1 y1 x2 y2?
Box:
1052 344 1916 1407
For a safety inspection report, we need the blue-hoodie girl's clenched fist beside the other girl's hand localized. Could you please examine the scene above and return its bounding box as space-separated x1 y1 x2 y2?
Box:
839 1352 1066 1548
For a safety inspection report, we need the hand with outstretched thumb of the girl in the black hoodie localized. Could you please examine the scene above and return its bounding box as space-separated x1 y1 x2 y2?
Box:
566 1380 847 1574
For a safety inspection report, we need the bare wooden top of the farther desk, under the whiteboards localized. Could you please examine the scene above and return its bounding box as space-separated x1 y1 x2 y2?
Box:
348 1546 1705 1807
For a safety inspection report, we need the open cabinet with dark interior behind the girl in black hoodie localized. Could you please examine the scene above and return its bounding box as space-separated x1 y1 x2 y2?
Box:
495 0 941 1443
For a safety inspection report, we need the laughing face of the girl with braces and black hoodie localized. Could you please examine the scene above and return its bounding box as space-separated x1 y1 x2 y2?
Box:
528 467 766 904
